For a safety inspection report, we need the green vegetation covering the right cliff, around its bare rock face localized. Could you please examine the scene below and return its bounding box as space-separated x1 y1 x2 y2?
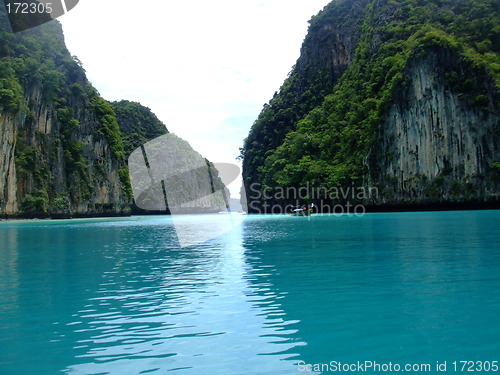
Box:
242 0 500 212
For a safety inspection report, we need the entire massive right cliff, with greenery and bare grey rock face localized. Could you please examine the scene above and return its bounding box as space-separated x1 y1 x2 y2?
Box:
241 0 500 212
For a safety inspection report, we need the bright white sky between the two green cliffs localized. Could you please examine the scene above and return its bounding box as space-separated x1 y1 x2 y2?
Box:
59 0 330 198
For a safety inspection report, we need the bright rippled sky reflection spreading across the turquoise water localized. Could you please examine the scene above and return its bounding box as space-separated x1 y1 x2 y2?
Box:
63 219 300 374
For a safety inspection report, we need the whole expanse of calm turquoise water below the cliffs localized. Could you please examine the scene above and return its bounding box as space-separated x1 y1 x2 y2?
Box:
0 211 500 375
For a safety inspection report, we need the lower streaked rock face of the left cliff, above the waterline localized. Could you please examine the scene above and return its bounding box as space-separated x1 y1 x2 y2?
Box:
0 76 131 217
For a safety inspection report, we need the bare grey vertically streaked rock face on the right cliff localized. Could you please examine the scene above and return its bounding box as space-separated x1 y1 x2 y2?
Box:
370 50 500 204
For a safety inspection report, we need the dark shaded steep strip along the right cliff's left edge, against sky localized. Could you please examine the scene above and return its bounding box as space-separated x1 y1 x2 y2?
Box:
242 0 369 191
